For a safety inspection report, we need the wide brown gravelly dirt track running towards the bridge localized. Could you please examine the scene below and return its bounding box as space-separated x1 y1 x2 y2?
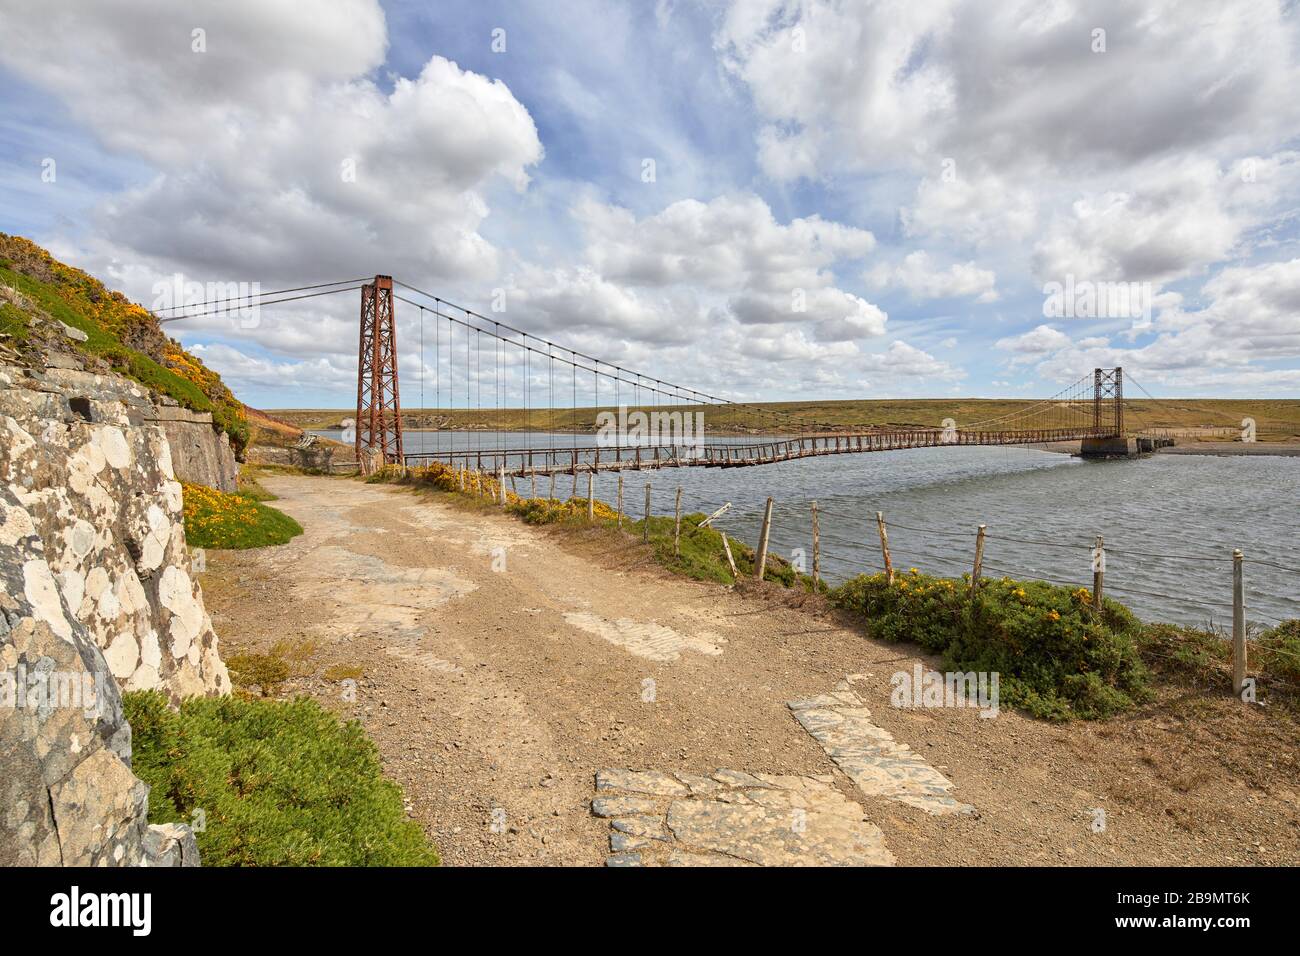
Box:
202 476 1300 865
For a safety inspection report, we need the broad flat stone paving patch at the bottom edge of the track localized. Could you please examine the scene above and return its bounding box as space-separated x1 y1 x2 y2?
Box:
592 770 893 866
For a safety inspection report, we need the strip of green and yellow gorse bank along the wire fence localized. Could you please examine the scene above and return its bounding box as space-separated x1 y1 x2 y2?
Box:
371 464 1300 721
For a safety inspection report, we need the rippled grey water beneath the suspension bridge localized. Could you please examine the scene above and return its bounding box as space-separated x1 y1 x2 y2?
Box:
321 432 1300 624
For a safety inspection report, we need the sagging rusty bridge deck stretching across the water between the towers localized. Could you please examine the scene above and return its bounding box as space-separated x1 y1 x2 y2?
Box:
403 428 1115 477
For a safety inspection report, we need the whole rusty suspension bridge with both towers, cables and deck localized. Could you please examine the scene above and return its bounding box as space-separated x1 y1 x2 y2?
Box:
355 276 1153 473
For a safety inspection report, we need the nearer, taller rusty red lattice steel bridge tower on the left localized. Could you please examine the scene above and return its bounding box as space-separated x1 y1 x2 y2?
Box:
356 276 403 464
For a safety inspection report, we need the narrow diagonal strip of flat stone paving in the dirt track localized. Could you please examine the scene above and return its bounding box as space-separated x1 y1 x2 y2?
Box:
787 680 975 814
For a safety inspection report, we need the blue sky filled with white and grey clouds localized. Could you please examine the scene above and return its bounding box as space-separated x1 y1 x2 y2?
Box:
0 0 1300 407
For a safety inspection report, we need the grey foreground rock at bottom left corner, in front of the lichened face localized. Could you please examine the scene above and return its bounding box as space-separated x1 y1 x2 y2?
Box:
0 486 198 866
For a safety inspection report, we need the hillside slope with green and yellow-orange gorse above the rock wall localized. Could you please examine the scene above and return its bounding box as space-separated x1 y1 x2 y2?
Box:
0 233 248 459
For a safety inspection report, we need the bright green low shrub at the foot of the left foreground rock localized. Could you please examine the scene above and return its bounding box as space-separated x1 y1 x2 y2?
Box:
124 691 438 866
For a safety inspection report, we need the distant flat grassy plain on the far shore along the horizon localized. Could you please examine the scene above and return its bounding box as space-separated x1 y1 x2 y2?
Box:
270 398 1300 442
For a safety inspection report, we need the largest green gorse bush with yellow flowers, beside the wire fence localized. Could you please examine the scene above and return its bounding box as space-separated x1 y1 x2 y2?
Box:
829 568 1149 721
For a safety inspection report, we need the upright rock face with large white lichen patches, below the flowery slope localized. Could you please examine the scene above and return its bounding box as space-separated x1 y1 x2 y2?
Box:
0 364 230 700
